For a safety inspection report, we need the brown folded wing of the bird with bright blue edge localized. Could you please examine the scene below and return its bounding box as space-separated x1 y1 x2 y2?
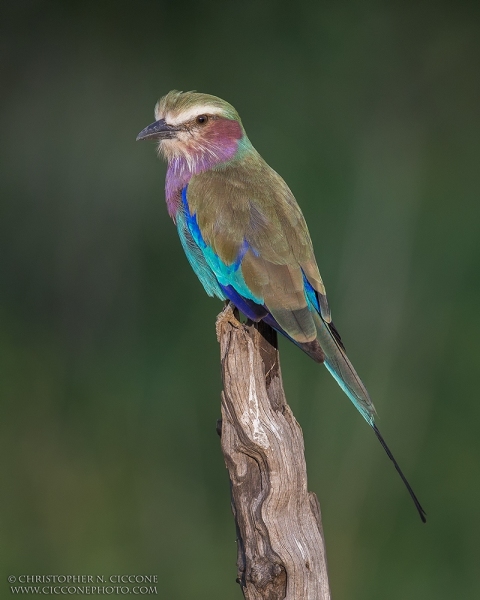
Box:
186 159 331 343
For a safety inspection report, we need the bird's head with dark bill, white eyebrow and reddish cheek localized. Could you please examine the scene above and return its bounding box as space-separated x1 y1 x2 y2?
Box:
137 90 248 171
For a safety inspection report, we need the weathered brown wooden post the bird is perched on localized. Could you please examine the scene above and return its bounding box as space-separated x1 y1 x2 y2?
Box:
217 305 330 600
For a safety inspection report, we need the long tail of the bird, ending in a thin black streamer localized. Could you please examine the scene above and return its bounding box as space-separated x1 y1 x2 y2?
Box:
315 314 427 523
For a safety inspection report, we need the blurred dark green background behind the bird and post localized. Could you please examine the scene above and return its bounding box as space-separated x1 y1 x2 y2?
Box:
0 0 480 600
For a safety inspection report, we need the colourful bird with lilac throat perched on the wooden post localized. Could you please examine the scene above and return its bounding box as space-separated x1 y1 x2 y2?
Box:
137 90 426 522
